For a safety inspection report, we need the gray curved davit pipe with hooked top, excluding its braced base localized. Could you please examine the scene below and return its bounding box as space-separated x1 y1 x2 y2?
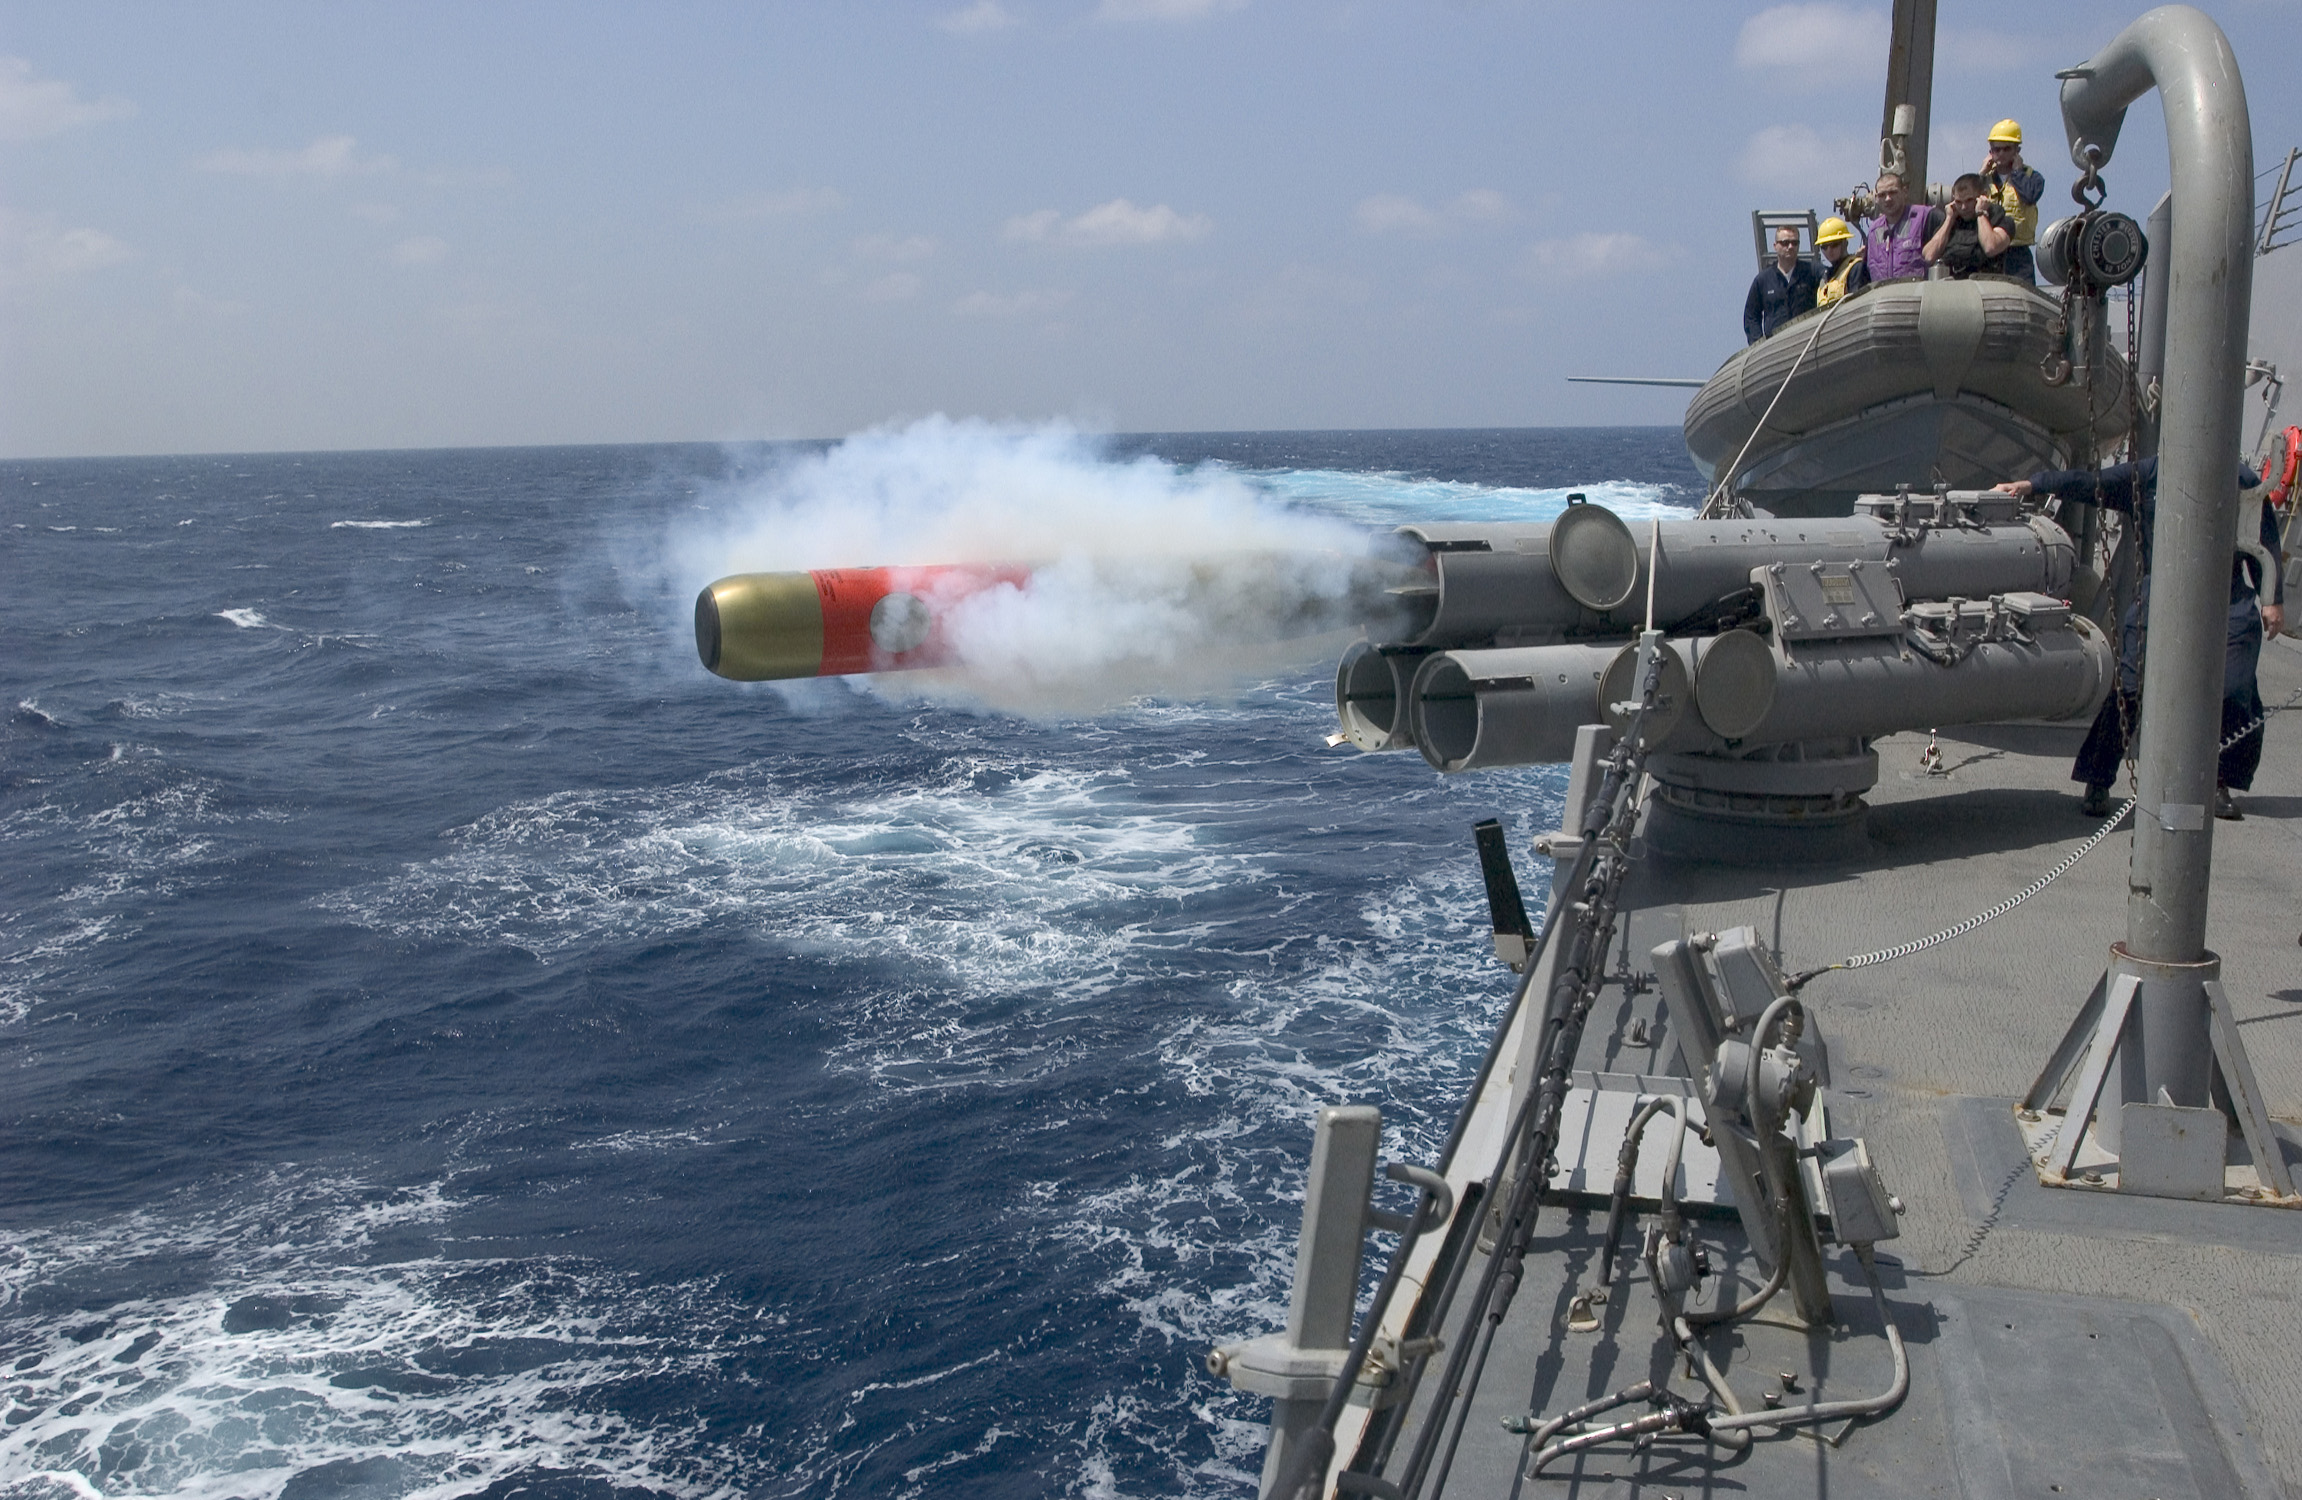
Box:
2063 5 2254 966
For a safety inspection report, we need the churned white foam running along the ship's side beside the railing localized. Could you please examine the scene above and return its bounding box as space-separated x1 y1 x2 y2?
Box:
1036 851 1540 1498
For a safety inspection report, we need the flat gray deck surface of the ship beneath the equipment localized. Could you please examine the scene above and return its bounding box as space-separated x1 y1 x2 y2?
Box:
1371 640 2302 1500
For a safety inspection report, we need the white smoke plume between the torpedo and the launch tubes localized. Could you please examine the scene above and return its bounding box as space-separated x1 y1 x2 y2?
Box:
674 416 1393 713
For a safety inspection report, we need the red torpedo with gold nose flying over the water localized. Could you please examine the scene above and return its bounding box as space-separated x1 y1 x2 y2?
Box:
695 564 1031 683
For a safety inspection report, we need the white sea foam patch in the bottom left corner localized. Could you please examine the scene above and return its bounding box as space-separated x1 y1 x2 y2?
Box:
0 1180 773 1500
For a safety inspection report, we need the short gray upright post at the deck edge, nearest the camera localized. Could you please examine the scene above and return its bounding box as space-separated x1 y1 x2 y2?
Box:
1206 1104 1384 1498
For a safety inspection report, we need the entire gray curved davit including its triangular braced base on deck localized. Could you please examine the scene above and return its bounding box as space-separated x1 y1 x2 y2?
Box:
2021 5 2286 1196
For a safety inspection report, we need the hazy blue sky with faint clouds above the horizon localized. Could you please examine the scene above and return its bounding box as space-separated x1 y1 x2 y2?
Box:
0 0 2302 456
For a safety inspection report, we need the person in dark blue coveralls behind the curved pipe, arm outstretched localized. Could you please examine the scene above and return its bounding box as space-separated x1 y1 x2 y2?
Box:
1998 458 2286 819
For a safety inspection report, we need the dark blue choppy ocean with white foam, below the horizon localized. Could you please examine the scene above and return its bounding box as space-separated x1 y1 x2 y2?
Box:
0 428 1699 1500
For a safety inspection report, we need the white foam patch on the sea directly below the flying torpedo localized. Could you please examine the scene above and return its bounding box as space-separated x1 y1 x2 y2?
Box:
320 755 1273 1108
